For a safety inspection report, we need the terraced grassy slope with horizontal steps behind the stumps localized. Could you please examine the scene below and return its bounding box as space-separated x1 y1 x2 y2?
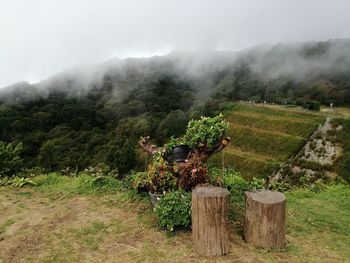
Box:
211 104 325 179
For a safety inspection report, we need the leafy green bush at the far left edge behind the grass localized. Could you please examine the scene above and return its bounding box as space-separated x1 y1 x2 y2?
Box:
0 141 23 178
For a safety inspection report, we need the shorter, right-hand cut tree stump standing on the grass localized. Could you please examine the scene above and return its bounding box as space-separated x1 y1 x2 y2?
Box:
244 191 286 248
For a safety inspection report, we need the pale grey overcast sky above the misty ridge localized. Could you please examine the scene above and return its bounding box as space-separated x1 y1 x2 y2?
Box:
0 0 350 88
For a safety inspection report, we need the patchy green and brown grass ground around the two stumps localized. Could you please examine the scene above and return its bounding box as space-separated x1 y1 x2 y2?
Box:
0 175 350 263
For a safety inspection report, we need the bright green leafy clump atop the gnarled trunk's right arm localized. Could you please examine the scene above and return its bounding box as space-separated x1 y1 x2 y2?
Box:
185 114 228 148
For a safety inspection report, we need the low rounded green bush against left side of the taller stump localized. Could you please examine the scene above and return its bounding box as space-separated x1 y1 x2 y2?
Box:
156 191 191 232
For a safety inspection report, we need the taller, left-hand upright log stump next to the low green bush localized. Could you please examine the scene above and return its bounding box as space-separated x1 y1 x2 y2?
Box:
192 185 230 256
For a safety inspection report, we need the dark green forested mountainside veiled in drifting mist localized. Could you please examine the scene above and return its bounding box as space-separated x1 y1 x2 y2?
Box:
0 40 350 174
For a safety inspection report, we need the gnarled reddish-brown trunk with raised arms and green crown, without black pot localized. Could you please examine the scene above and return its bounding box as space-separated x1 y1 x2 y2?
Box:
139 114 231 190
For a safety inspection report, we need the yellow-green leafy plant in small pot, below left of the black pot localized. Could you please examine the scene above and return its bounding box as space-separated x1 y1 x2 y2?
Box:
147 154 177 206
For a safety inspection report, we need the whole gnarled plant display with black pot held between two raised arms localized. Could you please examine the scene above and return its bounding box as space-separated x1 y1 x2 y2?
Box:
139 114 231 194
